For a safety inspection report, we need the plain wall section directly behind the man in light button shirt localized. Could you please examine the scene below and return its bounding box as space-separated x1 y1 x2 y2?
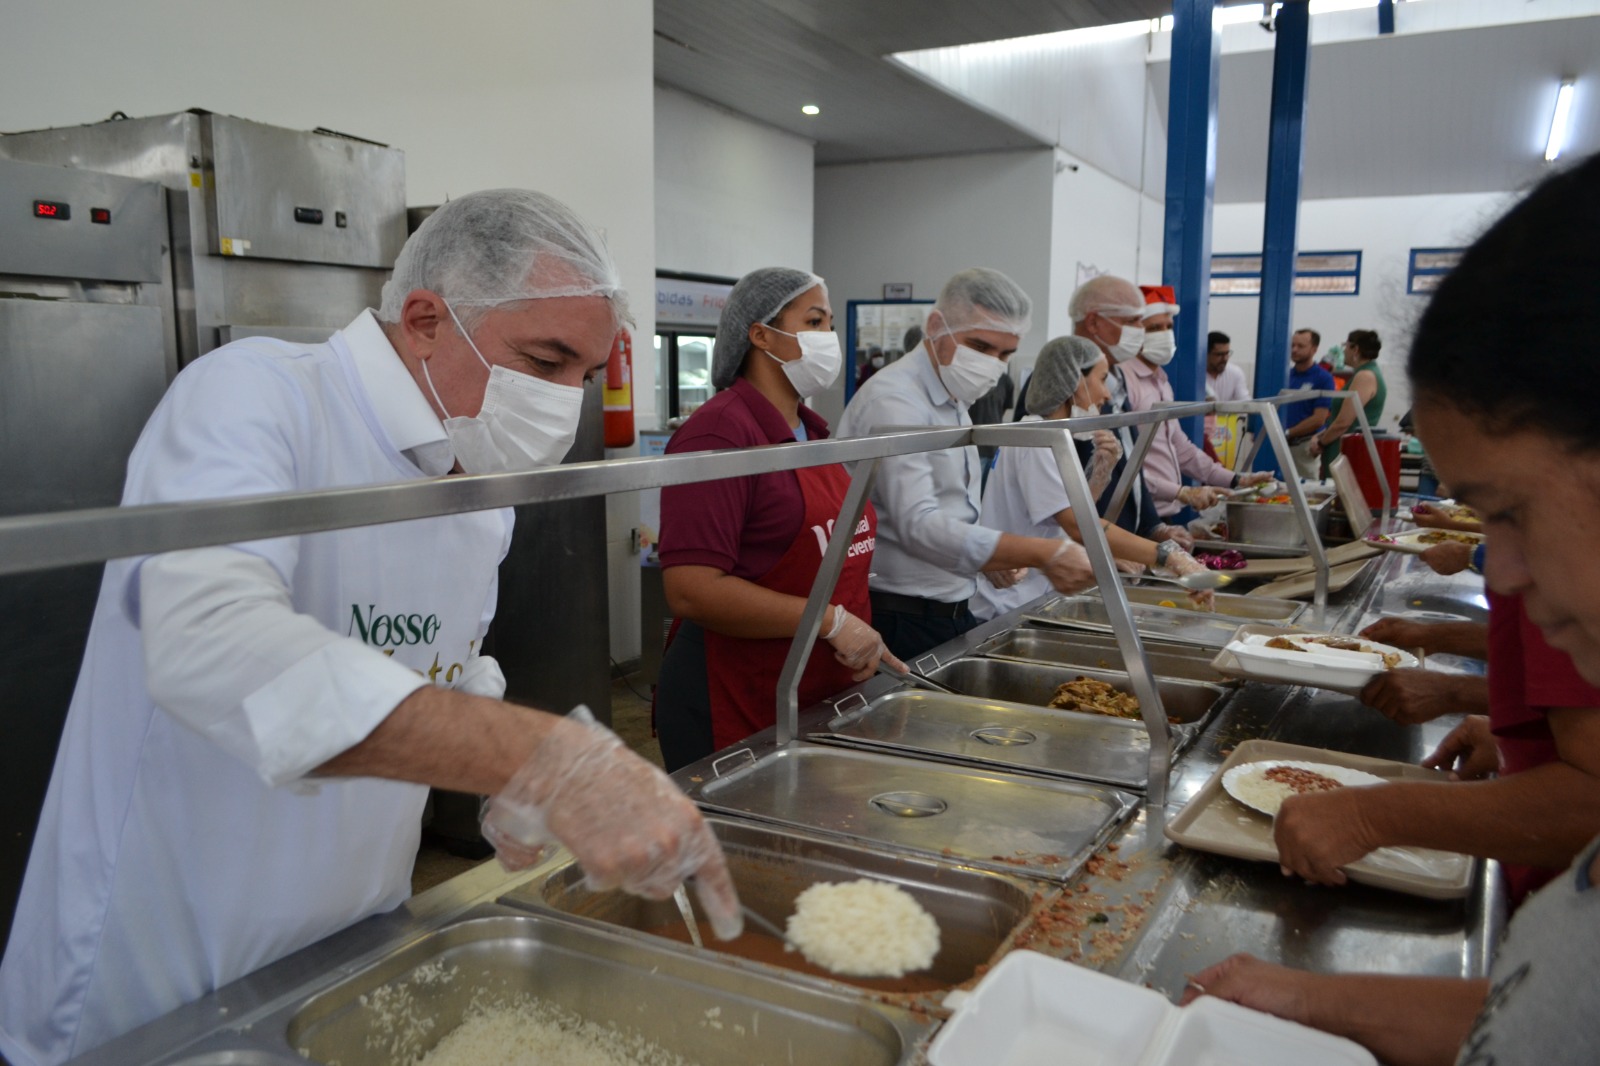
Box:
814 149 1056 423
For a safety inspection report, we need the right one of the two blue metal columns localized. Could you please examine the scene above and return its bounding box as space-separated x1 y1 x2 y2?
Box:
1256 0 1310 472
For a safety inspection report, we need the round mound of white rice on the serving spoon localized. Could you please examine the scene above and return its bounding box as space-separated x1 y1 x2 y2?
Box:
787 877 939 978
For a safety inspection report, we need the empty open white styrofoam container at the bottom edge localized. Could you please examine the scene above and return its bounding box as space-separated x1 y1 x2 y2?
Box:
928 951 1378 1066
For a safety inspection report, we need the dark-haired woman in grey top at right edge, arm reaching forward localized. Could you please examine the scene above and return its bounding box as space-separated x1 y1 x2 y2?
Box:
1189 157 1600 1066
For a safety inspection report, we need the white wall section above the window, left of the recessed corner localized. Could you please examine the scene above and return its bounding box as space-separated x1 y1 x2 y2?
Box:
656 85 816 277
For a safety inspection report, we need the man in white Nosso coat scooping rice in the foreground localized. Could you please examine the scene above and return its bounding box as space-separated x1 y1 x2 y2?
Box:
0 189 739 1066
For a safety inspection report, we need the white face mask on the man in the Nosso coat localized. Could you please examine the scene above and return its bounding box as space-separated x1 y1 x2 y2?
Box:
422 304 584 474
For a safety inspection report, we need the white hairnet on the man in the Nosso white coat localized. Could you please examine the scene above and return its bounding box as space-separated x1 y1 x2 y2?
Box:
378 189 630 328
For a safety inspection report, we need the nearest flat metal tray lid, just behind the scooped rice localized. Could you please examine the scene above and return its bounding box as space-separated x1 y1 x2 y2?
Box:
688 741 1138 880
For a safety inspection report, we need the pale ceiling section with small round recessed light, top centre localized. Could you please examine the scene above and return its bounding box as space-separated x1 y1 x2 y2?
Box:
656 0 1170 163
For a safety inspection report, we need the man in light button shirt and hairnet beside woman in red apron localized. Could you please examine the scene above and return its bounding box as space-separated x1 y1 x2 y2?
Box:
838 267 1094 663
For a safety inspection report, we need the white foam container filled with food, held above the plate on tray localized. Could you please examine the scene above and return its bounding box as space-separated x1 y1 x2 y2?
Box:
1211 626 1422 696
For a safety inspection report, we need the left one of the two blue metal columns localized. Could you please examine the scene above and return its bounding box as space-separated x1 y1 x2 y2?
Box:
1162 0 1222 443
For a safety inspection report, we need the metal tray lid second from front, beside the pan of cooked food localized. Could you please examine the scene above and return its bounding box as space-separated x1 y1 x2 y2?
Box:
806 691 1150 791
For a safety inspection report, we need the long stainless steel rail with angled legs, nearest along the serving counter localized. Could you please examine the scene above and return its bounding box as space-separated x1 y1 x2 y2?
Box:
0 393 1328 810
